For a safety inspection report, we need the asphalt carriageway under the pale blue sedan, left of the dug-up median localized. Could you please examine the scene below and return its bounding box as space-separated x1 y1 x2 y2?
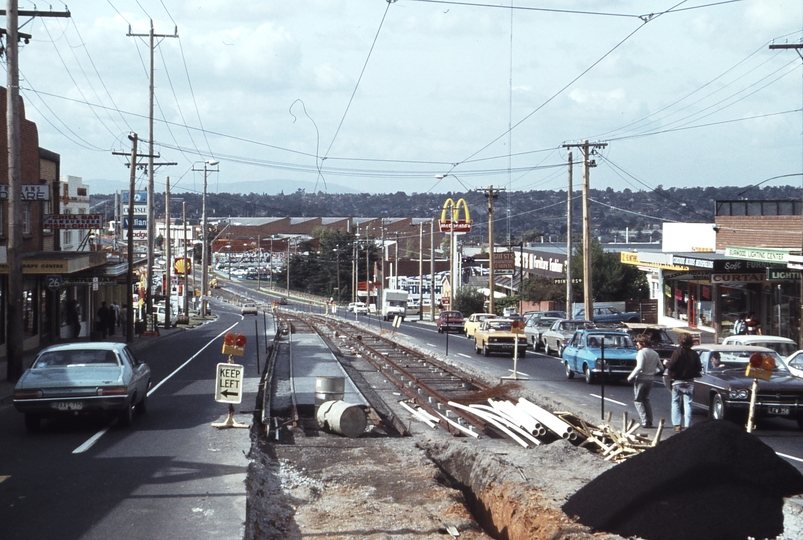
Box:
0 305 264 540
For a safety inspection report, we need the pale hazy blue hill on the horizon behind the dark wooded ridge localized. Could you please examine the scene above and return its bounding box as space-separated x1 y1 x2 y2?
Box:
84 178 361 195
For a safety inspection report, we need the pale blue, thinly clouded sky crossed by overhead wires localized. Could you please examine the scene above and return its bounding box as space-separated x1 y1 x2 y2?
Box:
11 0 803 198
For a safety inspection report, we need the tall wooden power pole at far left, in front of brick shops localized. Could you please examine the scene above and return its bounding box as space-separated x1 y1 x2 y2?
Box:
0 0 70 382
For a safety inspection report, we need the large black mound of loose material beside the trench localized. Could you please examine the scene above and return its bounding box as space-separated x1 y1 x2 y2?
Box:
563 421 803 540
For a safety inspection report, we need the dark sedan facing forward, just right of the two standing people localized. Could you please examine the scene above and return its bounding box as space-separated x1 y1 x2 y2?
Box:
693 345 803 429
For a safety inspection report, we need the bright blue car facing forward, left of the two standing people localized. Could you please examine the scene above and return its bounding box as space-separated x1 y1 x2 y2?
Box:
562 329 638 384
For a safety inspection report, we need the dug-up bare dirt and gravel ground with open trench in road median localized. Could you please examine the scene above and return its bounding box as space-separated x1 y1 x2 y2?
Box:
245 312 803 540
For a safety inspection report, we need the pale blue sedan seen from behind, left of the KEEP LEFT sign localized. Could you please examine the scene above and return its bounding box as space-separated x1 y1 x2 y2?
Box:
14 342 151 431
